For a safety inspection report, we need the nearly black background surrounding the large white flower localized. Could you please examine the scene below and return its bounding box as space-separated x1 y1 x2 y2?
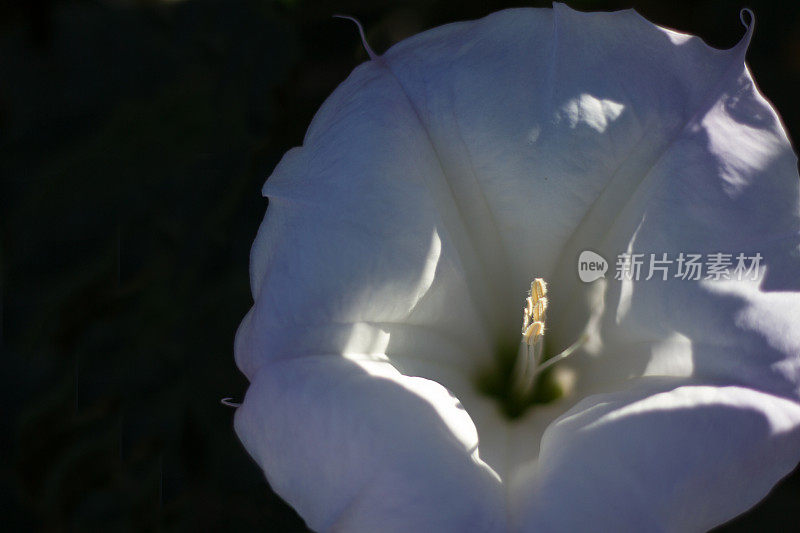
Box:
0 0 800 531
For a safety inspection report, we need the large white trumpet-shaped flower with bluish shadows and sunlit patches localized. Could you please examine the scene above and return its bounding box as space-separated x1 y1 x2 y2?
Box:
231 5 800 532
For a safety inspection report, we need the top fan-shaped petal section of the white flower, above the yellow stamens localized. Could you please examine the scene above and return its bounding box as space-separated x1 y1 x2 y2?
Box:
385 4 749 296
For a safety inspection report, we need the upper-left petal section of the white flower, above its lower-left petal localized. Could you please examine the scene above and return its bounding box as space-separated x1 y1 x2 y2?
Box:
236 57 490 376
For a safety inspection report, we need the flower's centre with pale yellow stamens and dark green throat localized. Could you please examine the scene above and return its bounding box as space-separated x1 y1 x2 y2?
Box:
477 278 586 420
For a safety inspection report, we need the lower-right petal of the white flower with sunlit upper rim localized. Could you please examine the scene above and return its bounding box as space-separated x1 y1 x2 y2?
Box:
515 379 800 532
